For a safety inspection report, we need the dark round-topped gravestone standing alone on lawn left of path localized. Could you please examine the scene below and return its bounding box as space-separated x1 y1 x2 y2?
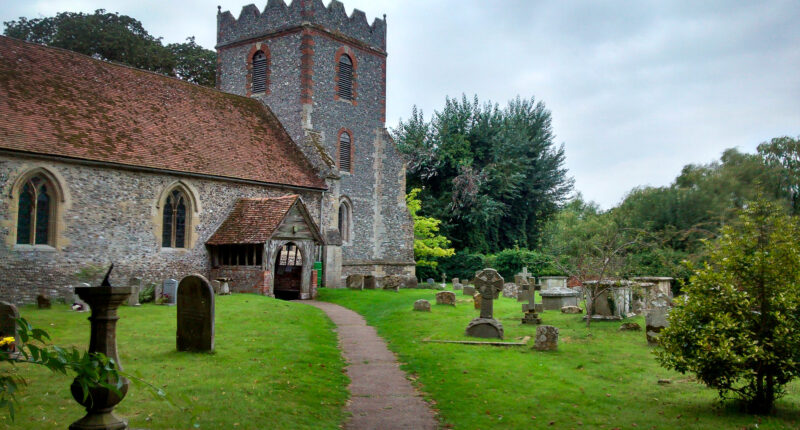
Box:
176 275 214 351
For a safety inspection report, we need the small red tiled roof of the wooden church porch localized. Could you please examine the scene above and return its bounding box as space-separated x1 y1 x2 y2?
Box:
206 195 298 245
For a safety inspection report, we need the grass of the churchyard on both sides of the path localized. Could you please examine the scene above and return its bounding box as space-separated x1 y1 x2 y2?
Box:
0 284 800 429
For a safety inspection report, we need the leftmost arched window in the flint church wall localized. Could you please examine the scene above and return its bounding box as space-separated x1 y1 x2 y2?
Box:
17 174 57 245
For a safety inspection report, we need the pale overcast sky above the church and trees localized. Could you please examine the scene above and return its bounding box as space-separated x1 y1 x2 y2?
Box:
0 0 800 208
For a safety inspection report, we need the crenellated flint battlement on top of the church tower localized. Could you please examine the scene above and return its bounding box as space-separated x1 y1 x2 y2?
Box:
217 0 386 51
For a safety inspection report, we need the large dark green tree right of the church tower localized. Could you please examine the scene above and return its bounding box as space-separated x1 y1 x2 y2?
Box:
394 96 572 253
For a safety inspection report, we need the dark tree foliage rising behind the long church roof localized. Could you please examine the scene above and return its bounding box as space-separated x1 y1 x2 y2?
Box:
4 9 216 86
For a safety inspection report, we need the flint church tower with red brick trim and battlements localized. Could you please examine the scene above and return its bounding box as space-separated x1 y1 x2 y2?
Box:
216 0 414 287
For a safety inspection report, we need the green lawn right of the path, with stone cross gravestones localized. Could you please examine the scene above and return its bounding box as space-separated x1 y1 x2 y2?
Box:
320 289 800 429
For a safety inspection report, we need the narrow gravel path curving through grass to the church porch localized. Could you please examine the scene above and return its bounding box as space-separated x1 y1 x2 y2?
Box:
303 301 438 430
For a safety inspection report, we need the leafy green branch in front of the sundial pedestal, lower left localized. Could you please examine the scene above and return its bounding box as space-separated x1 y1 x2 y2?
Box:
0 318 123 420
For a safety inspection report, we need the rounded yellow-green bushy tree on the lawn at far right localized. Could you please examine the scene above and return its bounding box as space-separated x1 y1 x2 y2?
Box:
657 199 800 414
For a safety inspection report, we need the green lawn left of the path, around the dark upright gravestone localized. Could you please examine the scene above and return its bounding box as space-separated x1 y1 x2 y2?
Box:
0 294 349 429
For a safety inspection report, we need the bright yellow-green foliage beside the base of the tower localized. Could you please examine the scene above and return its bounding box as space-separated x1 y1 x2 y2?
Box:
406 188 455 268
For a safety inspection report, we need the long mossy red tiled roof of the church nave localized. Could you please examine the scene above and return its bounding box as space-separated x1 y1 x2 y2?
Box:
0 36 325 189
